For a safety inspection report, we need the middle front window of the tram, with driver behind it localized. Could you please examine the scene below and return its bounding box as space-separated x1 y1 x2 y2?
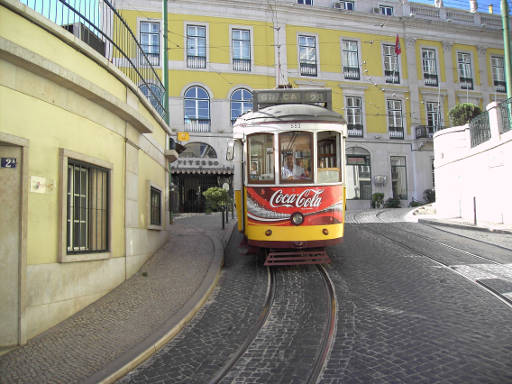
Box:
279 132 313 183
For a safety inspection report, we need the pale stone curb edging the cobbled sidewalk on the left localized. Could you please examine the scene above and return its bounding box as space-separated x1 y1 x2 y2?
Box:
83 220 236 384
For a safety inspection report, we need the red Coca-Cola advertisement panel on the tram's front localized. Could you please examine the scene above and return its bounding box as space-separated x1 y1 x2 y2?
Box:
247 185 343 225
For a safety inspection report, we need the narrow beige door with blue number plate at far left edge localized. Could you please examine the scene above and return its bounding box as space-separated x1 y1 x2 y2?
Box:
0 143 22 346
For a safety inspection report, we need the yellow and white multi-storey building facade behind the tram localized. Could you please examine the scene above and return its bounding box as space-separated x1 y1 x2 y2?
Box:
115 0 505 211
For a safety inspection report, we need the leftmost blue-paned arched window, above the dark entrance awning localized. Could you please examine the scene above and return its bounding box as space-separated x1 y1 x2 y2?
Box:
185 87 210 132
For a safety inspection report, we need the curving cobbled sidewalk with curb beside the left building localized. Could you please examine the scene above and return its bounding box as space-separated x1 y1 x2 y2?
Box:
0 213 235 384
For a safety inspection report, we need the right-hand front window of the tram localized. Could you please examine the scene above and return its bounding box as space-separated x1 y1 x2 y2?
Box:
317 132 341 183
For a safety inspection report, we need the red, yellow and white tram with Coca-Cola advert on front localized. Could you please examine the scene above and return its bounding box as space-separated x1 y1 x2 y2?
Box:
227 89 347 265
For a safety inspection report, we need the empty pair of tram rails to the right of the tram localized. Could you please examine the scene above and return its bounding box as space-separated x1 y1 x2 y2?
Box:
353 214 512 309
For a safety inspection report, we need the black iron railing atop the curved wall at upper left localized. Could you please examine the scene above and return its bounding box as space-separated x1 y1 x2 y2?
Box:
20 0 168 120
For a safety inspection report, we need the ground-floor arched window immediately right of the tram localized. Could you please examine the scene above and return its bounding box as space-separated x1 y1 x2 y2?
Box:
345 147 372 200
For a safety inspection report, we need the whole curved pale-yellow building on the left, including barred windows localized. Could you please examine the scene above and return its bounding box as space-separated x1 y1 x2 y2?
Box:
0 0 176 347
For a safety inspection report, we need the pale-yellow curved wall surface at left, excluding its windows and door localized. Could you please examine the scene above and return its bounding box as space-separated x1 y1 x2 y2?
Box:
0 0 170 345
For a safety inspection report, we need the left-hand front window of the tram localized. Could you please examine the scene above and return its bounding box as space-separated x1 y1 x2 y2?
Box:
247 133 274 183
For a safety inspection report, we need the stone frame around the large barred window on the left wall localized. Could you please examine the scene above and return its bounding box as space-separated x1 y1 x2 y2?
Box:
58 148 114 263
